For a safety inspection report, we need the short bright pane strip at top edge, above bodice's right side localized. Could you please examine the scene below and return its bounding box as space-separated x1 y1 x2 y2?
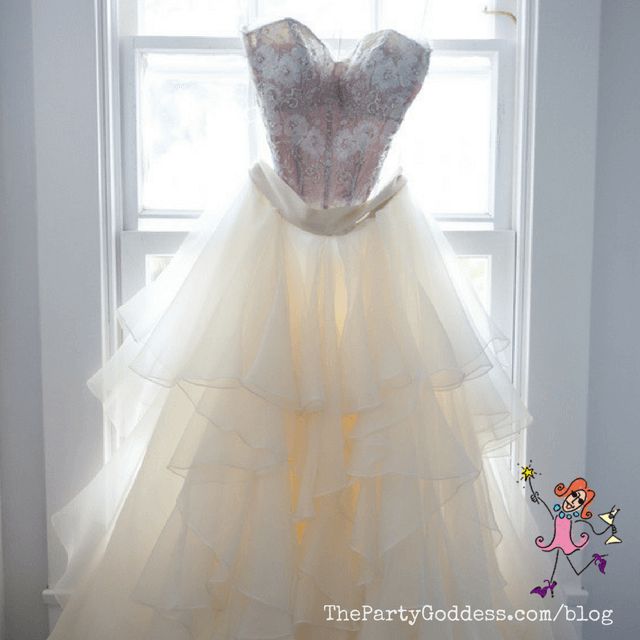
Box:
380 0 495 40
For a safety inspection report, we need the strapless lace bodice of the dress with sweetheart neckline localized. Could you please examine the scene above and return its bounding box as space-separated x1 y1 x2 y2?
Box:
243 18 431 208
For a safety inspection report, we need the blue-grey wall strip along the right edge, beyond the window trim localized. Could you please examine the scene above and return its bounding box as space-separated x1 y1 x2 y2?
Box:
585 0 640 640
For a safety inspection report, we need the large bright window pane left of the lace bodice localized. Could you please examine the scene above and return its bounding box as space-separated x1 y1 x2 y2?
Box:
140 53 249 210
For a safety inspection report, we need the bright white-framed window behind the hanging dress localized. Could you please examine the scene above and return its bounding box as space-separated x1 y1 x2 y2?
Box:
116 0 516 376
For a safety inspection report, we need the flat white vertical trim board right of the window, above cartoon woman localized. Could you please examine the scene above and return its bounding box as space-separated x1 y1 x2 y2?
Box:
522 0 601 552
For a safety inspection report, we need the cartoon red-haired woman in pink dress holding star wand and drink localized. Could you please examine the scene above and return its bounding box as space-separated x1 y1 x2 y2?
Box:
520 462 622 598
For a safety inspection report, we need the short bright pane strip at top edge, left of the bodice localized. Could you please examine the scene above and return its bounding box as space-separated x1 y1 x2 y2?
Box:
137 0 242 37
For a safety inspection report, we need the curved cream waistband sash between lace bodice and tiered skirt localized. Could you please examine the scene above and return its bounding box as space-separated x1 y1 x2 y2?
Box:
249 161 407 236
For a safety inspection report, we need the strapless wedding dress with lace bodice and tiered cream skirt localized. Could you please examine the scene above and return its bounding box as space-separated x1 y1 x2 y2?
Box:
50 18 573 640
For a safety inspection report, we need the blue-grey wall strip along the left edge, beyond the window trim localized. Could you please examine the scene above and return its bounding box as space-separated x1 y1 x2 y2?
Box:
0 0 47 640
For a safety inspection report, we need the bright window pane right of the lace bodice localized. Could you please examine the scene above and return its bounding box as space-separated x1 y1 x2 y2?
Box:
397 54 493 215
